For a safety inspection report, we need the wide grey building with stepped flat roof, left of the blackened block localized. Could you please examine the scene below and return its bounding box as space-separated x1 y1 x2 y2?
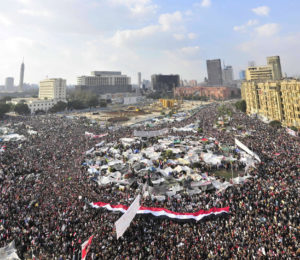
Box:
76 71 132 95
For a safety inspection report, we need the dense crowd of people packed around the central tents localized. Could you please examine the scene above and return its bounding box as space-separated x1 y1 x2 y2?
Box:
0 104 300 259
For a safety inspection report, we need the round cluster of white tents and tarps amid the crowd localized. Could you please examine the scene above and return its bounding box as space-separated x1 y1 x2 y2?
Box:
83 125 255 200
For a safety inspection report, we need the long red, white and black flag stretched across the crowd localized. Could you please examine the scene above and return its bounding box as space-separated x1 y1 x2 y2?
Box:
91 202 229 221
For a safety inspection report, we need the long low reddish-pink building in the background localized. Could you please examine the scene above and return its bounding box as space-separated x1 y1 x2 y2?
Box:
175 86 240 100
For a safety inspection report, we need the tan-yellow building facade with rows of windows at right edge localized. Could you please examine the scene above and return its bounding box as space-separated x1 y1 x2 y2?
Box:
242 80 300 129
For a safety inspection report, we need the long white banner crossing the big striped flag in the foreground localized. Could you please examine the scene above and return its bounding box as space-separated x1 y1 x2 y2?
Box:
115 195 141 239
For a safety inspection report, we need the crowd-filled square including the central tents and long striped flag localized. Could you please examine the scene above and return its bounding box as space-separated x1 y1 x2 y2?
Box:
0 102 300 260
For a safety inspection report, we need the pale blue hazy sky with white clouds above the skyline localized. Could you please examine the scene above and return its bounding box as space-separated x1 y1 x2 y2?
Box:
0 0 300 84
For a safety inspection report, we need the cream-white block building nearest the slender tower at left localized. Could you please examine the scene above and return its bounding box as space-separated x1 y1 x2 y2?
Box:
39 78 67 101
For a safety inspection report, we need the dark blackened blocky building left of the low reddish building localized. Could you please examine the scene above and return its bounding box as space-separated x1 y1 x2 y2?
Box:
151 75 180 92
